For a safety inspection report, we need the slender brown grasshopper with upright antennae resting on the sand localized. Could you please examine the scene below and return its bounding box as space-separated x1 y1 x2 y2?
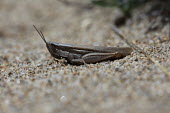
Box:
33 25 133 65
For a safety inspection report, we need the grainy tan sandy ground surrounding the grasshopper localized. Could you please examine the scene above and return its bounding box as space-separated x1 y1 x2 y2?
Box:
0 0 170 113
